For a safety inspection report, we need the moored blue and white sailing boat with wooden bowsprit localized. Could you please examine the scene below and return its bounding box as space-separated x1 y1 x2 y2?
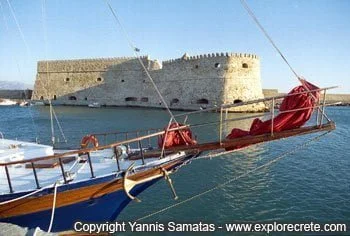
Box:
0 0 335 231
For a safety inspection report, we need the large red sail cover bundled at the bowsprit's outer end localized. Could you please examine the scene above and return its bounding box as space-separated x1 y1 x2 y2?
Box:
226 80 319 150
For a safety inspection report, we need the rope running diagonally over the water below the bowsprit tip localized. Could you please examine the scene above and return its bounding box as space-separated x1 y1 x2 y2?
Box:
135 131 331 222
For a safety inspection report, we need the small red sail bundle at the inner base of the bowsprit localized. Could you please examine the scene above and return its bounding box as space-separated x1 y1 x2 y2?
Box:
158 122 197 148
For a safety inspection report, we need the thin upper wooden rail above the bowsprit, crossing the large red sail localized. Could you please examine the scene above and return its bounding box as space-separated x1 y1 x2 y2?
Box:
174 86 338 117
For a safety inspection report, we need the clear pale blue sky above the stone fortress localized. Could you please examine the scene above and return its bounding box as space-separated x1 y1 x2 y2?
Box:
0 0 350 93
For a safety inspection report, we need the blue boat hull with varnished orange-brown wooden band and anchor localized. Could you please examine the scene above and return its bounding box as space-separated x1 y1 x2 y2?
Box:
0 155 193 232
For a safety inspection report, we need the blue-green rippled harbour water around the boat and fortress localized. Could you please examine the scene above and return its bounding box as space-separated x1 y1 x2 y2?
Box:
0 106 350 233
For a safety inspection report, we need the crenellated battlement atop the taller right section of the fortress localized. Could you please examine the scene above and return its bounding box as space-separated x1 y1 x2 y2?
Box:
163 52 259 64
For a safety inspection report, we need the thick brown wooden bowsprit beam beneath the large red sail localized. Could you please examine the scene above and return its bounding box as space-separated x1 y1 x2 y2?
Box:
129 122 335 160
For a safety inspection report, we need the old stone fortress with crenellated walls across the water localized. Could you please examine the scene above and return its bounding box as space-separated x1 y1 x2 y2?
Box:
32 53 265 112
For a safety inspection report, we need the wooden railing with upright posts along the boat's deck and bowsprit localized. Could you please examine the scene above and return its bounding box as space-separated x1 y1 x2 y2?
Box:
0 87 337 193
